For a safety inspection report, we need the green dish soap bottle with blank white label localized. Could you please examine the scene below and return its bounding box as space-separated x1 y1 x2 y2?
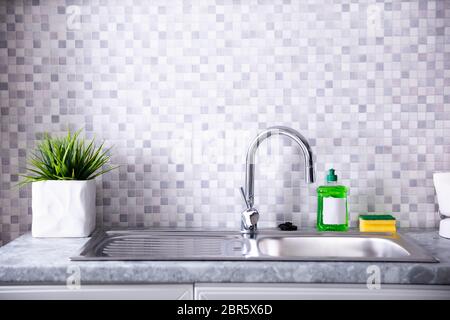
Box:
317 169 348 231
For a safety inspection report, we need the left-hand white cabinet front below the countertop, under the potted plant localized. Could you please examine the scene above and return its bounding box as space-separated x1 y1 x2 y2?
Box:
0 284 194 300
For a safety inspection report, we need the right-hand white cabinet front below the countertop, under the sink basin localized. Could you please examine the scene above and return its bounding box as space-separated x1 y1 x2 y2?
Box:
194 283 450 300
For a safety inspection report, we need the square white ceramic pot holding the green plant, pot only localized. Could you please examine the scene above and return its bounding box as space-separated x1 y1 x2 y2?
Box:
31 180 95 237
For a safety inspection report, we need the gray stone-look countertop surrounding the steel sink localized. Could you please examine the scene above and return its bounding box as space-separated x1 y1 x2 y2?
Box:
0 229 450 284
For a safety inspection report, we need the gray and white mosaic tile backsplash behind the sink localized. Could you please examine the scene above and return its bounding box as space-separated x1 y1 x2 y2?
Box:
0 0 450 243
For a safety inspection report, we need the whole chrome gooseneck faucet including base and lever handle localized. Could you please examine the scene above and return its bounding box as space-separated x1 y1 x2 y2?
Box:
241 126 315 233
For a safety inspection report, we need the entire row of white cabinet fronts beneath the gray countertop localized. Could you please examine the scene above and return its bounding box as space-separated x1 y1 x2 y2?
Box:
0 283 450 300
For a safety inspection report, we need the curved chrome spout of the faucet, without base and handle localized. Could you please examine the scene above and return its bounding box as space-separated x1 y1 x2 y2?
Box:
245 126 315 208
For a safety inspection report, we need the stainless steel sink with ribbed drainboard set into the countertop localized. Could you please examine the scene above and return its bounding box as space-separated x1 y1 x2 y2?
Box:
71 229 437 262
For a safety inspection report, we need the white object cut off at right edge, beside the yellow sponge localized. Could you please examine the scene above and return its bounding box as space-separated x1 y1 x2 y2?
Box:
433 172 450 238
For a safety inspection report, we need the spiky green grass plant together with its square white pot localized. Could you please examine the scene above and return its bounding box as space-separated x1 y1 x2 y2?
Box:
19 131 115 237
